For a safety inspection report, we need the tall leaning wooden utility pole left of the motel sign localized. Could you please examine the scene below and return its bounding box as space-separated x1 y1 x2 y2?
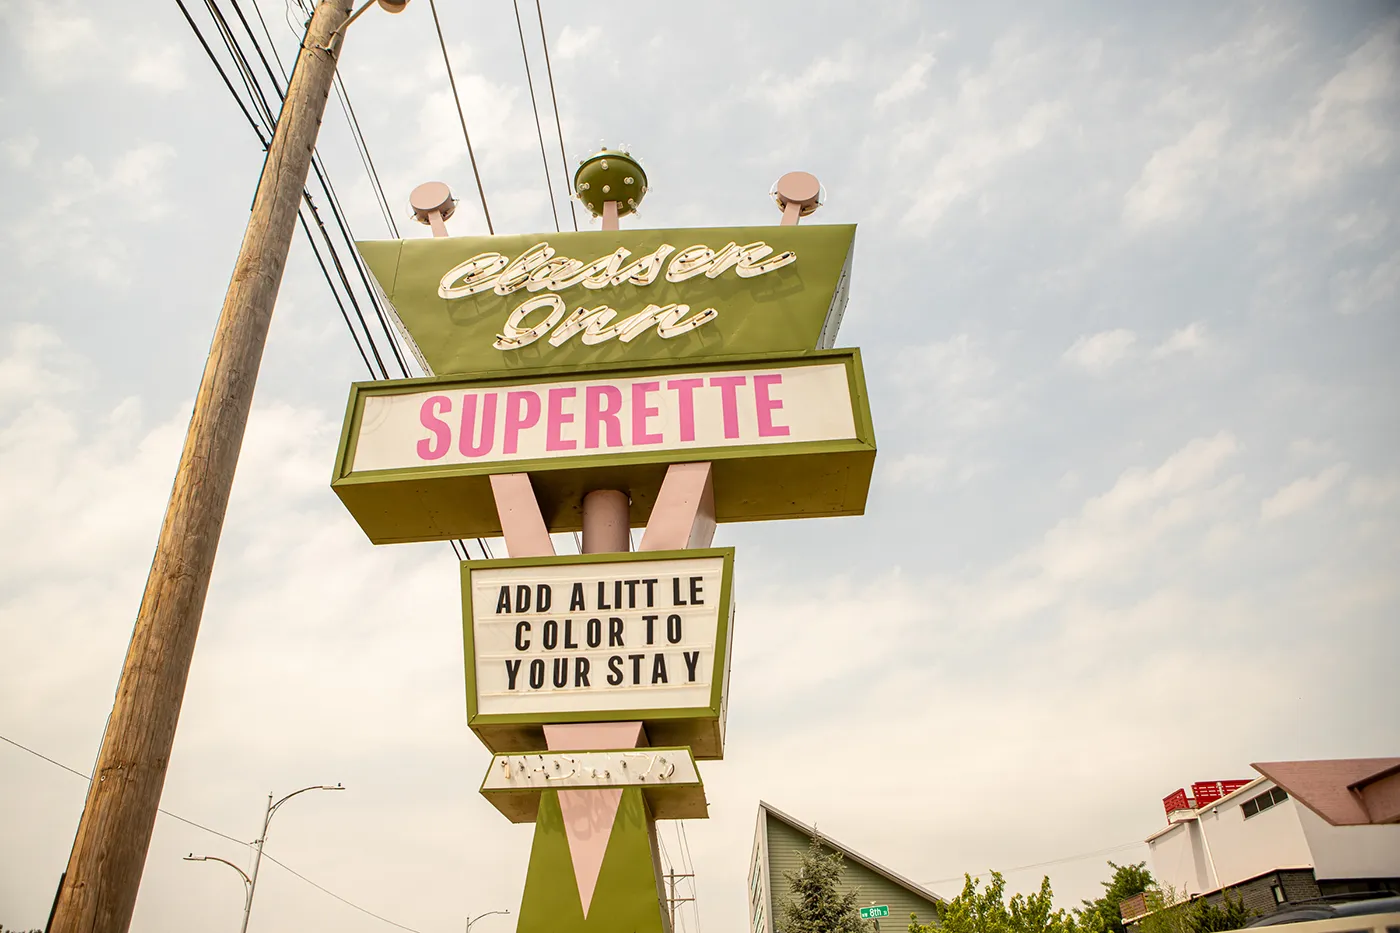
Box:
49 0 350 933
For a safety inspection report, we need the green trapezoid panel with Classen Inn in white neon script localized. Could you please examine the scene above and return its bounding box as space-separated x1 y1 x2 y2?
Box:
358 224 855 375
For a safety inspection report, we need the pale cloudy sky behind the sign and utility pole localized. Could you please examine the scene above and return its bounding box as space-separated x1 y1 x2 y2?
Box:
0 0 1400 933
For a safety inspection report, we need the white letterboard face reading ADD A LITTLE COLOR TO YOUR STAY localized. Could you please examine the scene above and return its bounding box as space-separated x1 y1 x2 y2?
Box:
468 555 728 716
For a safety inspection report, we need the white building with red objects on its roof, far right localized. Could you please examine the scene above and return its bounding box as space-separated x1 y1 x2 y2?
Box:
1124 759 1400 920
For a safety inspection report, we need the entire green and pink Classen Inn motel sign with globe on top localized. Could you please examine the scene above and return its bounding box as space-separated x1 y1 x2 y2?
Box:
332 150 875 933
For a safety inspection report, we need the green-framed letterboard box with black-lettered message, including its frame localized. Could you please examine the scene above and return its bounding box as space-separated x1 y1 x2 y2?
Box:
462 548 734 758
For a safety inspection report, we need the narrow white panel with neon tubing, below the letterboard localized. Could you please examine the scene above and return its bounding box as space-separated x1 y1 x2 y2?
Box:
482 748 700 793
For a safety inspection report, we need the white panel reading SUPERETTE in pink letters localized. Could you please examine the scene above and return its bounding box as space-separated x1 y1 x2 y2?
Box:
350 363 855 474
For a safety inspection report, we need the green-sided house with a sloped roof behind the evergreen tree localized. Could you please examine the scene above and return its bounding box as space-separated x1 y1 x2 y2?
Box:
749 800 944 933
